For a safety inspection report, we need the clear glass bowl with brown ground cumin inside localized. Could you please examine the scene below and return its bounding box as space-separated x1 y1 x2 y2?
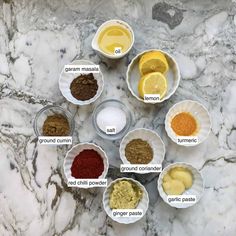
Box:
33 105 75 137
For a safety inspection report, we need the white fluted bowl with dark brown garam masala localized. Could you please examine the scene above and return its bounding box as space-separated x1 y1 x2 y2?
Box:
59 60 104 106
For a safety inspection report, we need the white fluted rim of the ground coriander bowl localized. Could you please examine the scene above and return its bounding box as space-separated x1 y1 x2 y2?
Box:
119 128 166 174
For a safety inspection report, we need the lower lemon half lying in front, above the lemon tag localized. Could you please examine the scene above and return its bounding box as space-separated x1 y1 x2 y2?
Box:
138 72 167 99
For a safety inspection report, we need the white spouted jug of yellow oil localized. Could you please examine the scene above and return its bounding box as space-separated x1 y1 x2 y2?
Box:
92 20 134 59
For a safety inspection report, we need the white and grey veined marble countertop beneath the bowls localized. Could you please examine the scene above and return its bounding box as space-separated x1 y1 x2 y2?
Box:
0 0 236 236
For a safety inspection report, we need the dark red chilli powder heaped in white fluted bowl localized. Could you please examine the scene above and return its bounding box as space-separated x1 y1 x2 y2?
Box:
70 149 104 179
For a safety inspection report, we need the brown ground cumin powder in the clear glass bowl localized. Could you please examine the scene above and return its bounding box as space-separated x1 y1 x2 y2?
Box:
43 114 70 136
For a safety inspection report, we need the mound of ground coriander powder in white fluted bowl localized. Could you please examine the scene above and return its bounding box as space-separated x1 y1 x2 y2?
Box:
125 139 153 164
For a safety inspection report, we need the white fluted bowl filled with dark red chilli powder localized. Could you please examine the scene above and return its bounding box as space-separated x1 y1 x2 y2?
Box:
64 143 109 180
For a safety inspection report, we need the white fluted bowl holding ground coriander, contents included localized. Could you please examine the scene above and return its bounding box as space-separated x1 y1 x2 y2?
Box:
120 128 165 173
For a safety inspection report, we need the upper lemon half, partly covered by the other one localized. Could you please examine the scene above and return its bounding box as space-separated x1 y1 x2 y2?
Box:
139 51 169 75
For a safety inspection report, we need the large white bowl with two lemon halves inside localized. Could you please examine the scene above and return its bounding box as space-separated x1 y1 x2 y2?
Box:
126 49 180 104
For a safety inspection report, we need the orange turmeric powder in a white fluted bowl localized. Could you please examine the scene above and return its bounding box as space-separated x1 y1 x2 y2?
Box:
171 112 197 136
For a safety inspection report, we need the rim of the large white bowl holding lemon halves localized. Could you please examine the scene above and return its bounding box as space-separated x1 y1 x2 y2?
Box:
126 49 181 105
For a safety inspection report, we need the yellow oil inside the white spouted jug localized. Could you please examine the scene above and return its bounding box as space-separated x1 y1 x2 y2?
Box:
98 25 132 55
